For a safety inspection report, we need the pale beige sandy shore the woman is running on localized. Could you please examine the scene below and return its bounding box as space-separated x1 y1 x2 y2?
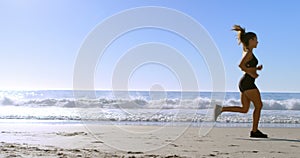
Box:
0 123 300 158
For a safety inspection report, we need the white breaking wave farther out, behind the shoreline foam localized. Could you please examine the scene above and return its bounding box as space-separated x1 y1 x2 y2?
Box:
0 97 300 110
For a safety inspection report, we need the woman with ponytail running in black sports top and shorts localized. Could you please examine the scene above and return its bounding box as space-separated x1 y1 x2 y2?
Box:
214 25 268 138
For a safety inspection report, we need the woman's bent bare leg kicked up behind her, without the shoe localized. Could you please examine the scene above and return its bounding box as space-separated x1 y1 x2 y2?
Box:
222 92 250 113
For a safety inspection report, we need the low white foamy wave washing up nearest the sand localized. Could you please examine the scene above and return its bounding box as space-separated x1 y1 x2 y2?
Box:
0 106 300 124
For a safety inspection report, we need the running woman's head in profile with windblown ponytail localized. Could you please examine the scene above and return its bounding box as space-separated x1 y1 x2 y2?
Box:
232 25 258 50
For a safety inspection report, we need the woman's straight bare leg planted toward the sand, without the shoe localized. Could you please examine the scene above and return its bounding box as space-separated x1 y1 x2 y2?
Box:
244 89 263 132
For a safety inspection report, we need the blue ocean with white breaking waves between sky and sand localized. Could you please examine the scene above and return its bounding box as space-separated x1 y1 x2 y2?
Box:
0 90 300 128
